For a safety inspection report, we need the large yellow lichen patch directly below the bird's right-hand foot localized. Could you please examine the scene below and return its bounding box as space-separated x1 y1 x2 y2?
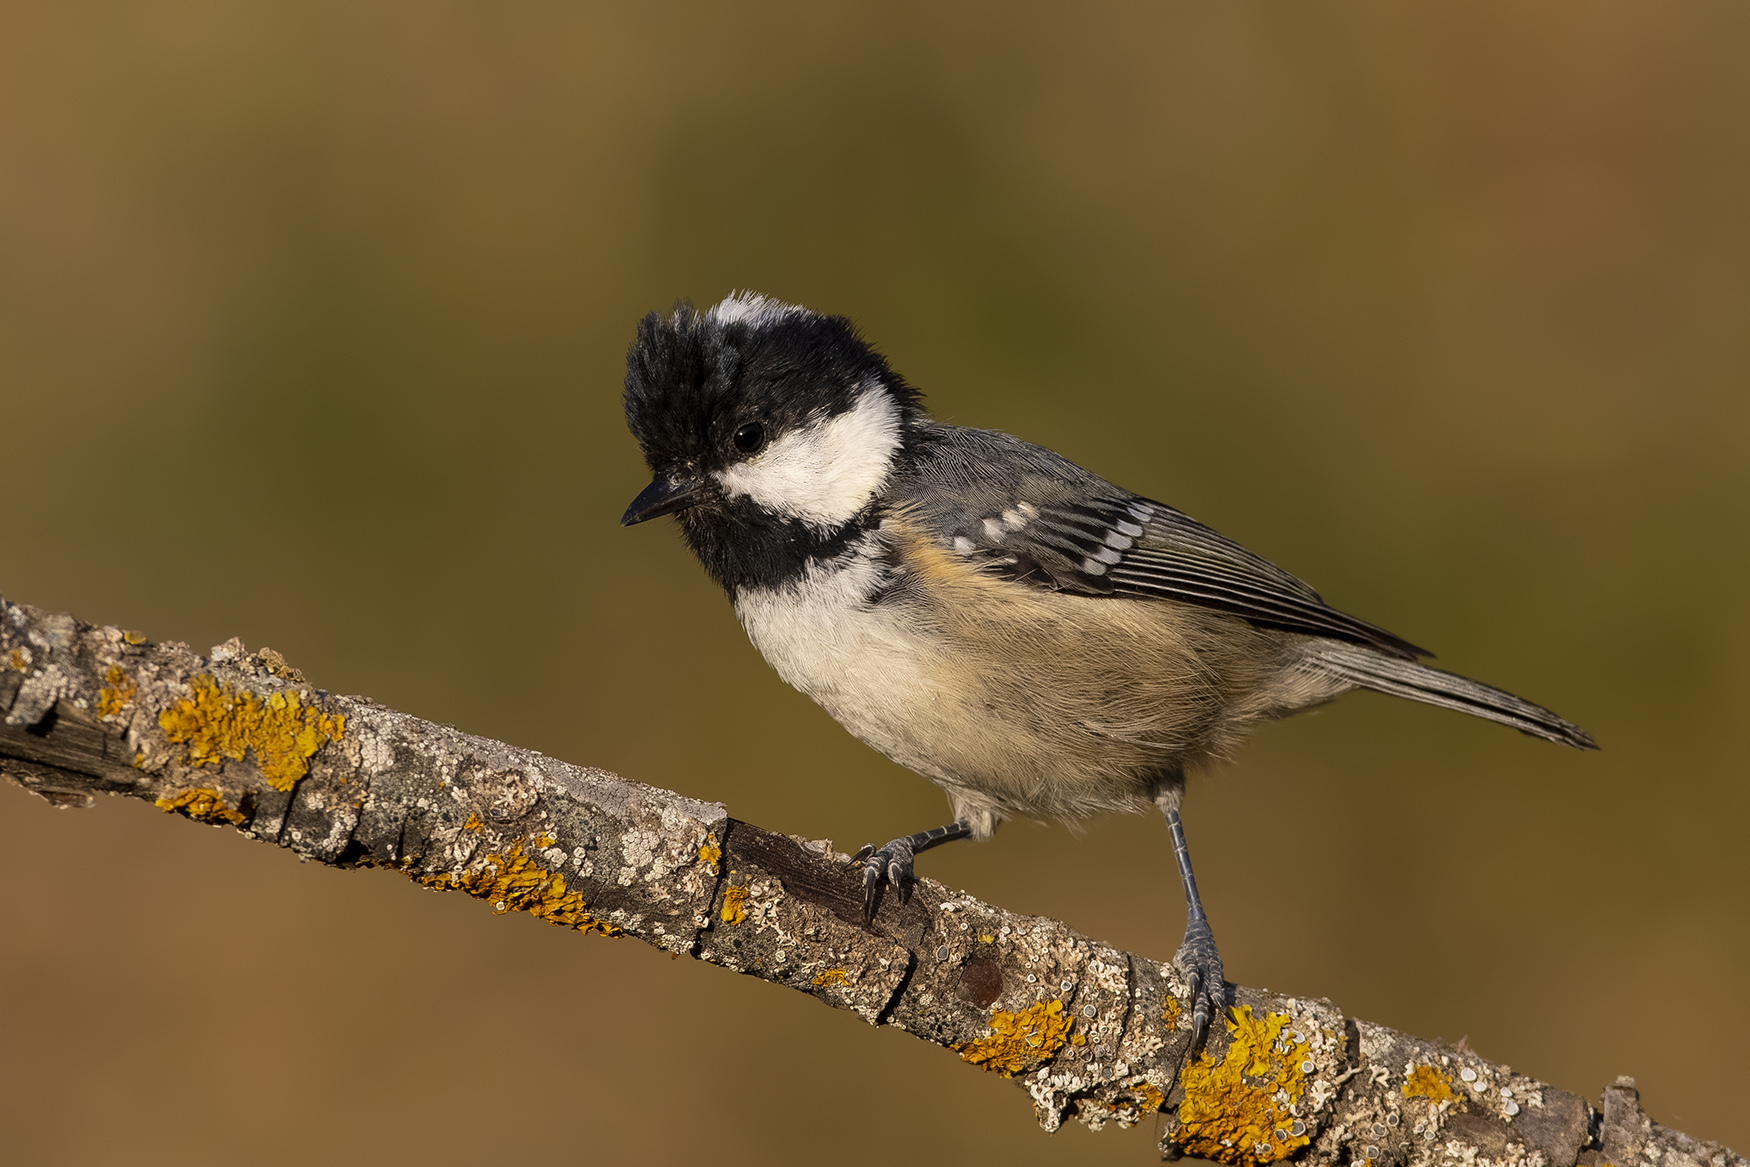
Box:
1173 1004 1311 1165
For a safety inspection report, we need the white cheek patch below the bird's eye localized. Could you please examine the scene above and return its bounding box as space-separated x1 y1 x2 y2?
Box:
716 381 900 530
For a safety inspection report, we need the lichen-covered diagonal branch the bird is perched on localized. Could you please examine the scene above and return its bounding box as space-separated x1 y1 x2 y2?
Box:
0 598 1750 1167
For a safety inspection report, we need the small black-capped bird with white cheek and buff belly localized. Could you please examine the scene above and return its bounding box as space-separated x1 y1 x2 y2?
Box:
621 292 1596 1048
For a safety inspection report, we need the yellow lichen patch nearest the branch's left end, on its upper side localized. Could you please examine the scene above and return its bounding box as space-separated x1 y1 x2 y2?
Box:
158 674 347 791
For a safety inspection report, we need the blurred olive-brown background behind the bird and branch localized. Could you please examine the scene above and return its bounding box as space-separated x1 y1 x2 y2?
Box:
0 0 1750 1164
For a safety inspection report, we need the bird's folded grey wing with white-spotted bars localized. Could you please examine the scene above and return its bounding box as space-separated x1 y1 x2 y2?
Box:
914 427 1430 660
